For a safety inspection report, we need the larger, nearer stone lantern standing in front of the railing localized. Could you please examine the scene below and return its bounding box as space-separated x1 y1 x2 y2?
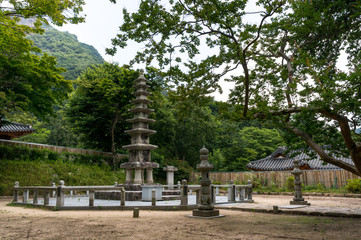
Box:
193 147 221 218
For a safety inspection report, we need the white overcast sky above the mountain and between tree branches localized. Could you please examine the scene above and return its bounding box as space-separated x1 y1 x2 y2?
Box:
57 0 347 101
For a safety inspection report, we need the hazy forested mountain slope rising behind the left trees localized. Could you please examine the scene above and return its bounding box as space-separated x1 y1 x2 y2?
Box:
28 25 104 80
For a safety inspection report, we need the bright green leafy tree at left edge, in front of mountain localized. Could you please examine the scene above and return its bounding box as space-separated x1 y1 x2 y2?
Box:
0 0 84 124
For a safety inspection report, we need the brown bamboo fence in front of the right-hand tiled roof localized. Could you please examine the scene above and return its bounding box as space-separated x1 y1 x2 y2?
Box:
189 170 360 188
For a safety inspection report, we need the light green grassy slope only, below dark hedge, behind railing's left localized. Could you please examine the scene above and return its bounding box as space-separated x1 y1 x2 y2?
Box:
0 159 125 196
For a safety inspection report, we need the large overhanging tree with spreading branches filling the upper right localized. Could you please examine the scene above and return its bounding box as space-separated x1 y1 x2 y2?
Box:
108 0 361 175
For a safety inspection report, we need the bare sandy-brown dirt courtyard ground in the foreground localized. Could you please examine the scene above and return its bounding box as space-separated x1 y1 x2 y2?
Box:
0 196 361 240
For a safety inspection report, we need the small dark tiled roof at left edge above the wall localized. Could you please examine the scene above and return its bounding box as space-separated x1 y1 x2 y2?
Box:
0 121 34 139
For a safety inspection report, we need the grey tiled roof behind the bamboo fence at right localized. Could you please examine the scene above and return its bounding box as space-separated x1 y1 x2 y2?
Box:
247 147 354 171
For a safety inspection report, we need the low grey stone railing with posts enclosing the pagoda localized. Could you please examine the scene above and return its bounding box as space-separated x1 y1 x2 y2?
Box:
13 180 253 210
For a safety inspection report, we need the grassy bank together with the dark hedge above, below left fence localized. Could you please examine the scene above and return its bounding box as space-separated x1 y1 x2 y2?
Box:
0 145 125 195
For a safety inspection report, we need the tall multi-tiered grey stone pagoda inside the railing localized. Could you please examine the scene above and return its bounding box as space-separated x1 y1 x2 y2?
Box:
120 70 159 187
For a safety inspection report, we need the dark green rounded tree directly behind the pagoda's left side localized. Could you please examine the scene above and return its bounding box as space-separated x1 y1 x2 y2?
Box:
65 63 138 152
